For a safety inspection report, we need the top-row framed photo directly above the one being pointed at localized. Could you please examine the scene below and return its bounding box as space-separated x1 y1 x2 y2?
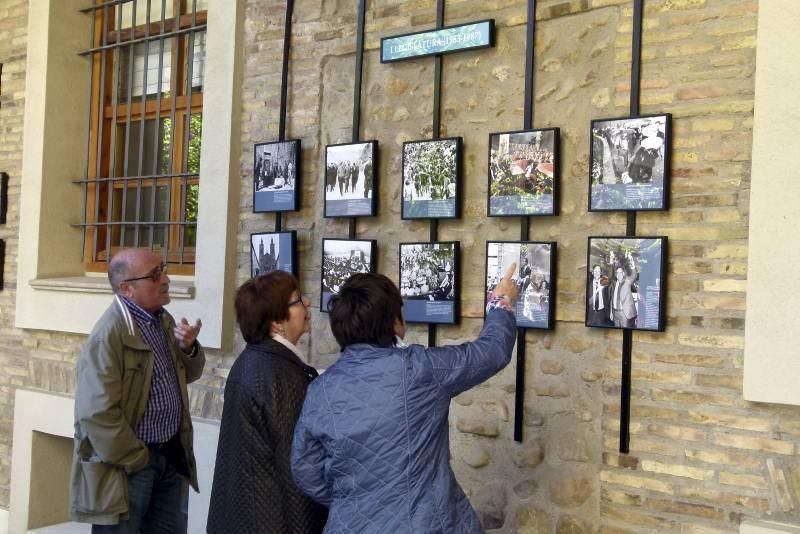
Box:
488 128 561 217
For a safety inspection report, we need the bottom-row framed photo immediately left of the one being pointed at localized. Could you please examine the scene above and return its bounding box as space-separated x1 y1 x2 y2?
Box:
400 241 461 324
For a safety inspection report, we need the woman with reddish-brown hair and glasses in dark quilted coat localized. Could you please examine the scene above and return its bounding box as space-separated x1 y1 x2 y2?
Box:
207 271 328 534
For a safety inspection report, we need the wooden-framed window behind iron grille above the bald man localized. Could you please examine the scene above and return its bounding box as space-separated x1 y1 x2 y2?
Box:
80 0 208 274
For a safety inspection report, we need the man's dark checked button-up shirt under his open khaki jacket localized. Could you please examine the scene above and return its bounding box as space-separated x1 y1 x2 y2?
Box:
122 297 183 444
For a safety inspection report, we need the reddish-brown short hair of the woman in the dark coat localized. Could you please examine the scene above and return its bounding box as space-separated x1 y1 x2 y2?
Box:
235 271 300 343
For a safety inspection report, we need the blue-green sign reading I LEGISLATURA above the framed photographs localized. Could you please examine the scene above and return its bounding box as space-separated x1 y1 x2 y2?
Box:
381 19 494 63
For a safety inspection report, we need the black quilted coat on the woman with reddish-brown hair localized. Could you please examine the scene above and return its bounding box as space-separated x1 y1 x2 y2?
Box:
208 339 328 534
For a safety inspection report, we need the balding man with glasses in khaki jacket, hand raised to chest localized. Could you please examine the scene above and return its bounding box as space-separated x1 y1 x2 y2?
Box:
70 248 205 534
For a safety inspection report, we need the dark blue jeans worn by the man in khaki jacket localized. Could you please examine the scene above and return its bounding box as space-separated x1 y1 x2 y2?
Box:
92 447 189 534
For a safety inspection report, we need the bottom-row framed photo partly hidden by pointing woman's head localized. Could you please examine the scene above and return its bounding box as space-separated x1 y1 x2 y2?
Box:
319 238 378 313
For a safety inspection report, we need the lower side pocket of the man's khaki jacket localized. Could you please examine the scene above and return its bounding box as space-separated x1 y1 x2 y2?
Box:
75 460 128 514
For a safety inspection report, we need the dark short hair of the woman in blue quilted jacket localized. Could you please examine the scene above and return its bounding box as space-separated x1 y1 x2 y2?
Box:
328 273 403 350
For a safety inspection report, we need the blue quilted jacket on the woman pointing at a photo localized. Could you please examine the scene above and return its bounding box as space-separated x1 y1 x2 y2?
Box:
292 309 516 534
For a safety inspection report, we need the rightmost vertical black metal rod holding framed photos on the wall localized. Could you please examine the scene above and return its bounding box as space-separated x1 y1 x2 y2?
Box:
619 0 644 454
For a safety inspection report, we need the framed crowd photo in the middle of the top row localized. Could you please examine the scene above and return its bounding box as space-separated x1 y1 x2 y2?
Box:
401 137 461 219
